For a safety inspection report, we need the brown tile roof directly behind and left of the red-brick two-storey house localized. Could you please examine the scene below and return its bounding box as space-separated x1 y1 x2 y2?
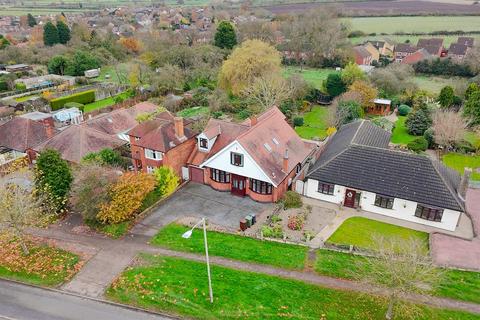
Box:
85 102 158 135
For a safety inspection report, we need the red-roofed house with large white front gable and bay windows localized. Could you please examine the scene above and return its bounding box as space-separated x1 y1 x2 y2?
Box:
188 107 317 202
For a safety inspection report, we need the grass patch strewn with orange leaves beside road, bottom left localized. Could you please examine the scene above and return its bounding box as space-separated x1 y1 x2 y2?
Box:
0 239 80 287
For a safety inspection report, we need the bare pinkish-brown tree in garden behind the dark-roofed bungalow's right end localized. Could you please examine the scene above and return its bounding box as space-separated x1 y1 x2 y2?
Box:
432 110 469 148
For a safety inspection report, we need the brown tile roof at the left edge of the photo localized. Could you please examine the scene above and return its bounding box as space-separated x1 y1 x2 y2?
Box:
0 117 57 152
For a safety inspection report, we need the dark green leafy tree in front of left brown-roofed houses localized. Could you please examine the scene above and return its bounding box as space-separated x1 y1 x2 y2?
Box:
35 149 73 212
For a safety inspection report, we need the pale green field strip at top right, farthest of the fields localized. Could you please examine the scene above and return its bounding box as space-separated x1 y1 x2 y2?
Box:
344 16 480 34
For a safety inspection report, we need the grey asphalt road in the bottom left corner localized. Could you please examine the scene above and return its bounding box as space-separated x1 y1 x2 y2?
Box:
0 280 174 320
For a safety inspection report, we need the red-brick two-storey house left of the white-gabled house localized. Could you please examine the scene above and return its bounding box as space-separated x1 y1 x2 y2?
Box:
128 111 196 177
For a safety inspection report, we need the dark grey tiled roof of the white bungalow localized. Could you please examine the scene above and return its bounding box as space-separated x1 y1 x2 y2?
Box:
307 120 464 211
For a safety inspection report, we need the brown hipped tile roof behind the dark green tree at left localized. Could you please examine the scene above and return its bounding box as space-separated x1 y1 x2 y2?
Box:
34 125 126 163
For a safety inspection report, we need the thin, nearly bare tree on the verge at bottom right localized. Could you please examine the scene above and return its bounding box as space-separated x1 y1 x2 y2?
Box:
353 237 442 319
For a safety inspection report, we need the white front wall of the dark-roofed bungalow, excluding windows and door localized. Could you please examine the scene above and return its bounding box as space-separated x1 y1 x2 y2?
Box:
304 179 461 231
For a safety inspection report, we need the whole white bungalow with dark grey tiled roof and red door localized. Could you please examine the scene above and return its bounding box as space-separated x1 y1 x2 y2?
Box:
303 120 465 231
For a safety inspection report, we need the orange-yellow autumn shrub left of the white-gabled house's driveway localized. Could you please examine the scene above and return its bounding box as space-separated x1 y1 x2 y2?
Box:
97 172 156 223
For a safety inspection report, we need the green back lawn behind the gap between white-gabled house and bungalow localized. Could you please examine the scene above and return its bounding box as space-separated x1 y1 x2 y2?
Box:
295 106 328 140
